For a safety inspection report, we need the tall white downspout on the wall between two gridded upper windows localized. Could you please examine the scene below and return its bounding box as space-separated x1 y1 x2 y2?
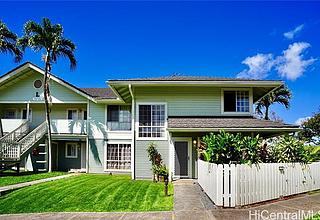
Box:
129 84 135 179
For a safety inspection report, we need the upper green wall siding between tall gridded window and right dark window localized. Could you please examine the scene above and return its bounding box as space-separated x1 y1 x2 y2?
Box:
134 86 221 116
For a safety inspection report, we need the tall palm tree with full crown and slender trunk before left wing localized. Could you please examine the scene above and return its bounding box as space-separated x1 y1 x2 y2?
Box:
18 18 77 172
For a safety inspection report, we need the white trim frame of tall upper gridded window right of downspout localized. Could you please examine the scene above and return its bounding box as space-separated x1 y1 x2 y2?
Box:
135 102 168 141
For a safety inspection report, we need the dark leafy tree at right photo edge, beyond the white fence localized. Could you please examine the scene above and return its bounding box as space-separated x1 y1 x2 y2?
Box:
299 112 320 145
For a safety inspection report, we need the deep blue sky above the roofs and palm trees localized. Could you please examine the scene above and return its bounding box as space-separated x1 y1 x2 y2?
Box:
0 1 320 123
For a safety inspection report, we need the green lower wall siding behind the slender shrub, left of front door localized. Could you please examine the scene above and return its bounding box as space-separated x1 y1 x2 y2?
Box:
135 140 169 179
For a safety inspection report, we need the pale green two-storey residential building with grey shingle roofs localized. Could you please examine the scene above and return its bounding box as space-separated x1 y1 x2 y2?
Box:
0 63 298 178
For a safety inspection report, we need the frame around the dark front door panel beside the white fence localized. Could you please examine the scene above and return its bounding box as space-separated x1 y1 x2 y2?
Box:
171 137 193 179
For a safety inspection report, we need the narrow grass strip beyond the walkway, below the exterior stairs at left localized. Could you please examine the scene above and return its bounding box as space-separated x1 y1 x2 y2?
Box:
0 172 66 187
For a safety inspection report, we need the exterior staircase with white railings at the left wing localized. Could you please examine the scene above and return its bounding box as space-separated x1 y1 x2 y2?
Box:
0 122 47 166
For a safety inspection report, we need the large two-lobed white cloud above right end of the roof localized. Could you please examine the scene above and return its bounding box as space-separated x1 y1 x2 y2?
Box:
237 42 316 80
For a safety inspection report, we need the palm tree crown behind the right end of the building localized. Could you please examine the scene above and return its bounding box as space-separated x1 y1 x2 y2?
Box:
256 86 292 120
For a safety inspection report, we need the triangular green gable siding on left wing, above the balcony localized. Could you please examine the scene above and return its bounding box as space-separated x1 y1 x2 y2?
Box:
0 71 87 103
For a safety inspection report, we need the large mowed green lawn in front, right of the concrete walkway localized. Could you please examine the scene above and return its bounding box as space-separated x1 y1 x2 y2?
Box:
0 174 173 214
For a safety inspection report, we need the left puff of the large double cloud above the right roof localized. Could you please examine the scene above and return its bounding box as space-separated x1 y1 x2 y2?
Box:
237 53 274 79
